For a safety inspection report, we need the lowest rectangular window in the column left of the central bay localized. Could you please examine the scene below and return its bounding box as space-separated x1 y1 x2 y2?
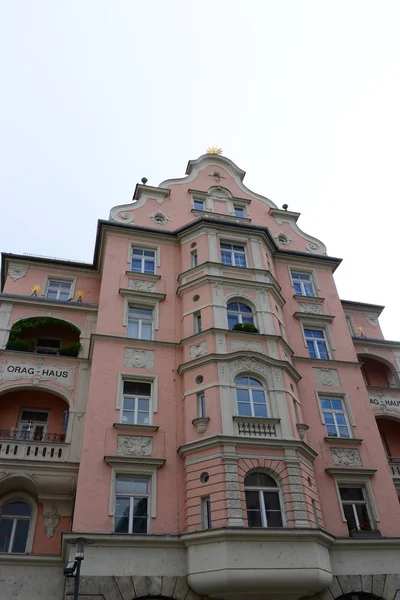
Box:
114 476 149 534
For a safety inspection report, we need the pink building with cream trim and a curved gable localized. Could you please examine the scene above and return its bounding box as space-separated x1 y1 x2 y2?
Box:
0 154 400 600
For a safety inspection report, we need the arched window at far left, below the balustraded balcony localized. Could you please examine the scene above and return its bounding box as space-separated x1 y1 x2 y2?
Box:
0 500 32 554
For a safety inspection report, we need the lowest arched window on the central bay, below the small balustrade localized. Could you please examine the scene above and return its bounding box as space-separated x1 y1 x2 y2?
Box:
244 471 283 527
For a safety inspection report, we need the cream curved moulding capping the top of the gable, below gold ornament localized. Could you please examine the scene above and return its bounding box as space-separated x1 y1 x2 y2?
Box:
159 154 278 208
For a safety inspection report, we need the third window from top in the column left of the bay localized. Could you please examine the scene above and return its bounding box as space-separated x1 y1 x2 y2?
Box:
121 381 151 425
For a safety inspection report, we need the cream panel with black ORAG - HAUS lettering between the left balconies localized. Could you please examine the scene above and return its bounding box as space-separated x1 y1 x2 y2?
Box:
0 359 75 390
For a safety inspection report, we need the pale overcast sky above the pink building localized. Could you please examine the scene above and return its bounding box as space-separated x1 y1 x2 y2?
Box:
0 0 400 340
